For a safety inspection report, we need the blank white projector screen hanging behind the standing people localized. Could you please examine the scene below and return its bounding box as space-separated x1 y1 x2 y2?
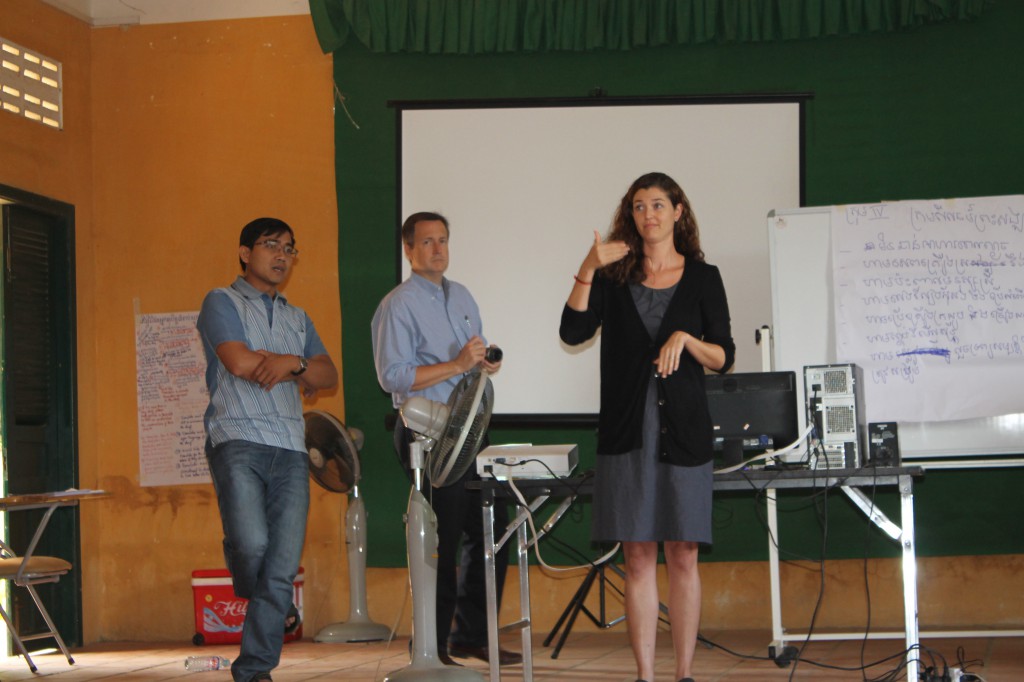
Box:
396 98 801 417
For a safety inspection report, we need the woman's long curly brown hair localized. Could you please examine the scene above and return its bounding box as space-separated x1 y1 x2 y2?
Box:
603 173 705 284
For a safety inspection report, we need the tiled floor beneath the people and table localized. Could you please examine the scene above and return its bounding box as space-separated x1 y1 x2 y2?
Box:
0 626 1024 682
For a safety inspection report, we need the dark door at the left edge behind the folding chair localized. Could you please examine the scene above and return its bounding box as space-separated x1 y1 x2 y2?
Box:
0 186 82 650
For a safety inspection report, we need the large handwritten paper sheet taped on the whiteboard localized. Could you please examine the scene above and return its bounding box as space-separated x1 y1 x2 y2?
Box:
831 196 1024 421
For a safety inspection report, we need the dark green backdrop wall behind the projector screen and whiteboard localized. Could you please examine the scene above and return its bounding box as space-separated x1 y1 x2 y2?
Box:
335 1 1024 566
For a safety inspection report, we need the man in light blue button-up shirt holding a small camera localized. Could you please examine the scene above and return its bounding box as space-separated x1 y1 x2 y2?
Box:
371 213 522 665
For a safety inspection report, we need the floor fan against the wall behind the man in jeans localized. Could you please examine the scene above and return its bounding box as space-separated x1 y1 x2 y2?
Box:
304 410 391 642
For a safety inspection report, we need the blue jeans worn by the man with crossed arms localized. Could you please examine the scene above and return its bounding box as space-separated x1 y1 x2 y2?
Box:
206 440 309 682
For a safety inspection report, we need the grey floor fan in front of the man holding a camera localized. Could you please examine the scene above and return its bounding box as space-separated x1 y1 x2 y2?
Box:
384 371 494 682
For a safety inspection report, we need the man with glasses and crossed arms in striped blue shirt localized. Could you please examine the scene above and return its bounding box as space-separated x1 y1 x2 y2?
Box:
197 218 338 682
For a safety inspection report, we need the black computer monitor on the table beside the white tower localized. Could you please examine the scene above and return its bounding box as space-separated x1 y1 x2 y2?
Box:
705 372 800 464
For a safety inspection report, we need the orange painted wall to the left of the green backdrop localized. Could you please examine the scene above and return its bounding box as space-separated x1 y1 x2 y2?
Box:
0 0 348 642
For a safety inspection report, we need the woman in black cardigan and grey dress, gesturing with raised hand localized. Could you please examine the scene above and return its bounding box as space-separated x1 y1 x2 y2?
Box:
559 173 735 682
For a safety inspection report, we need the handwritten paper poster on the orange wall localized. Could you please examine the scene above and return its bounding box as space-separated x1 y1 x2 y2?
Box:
135 311 210 486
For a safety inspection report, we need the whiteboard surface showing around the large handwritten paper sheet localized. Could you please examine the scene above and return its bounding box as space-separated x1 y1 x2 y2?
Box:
767 202 1024 458
